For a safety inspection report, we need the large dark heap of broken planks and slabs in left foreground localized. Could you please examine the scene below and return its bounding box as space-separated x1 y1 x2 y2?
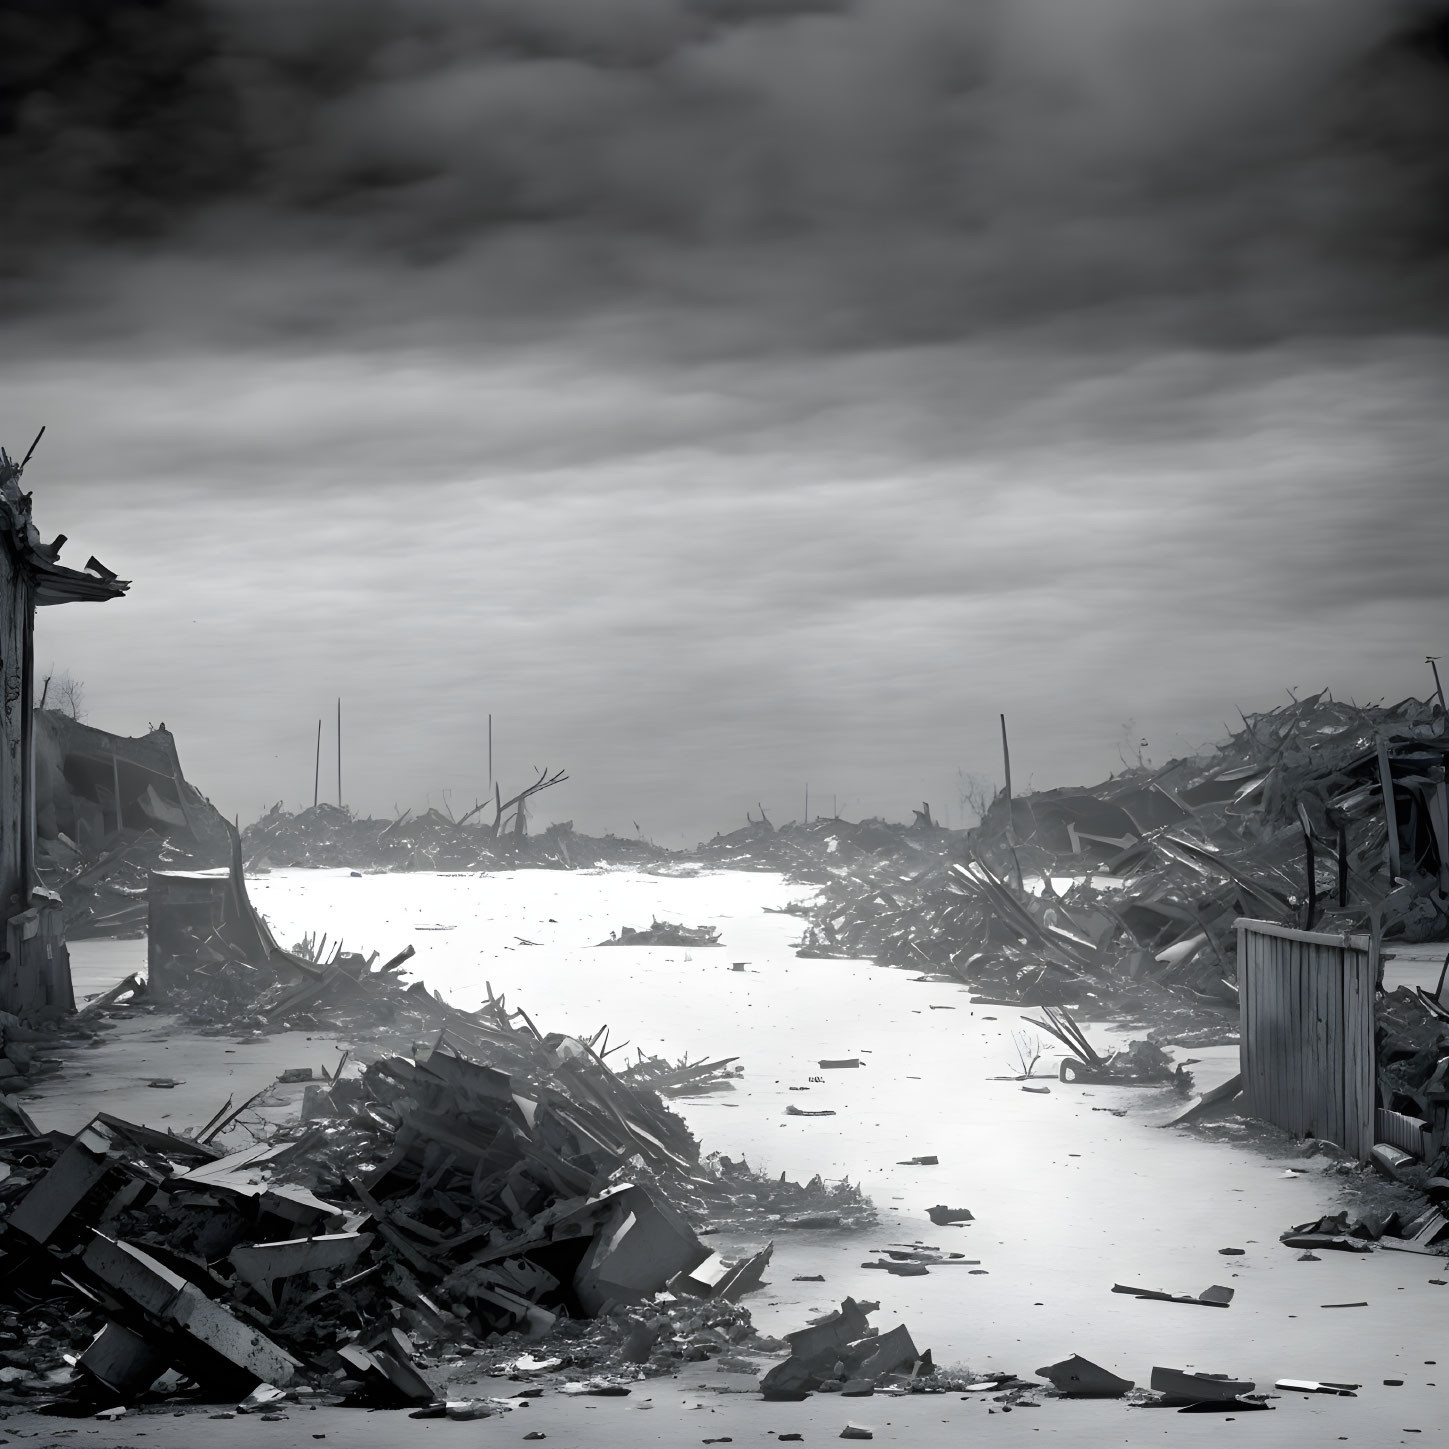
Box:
0 956 874 1410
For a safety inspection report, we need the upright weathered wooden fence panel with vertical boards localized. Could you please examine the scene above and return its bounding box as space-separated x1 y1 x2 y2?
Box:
1237 920 1377 1159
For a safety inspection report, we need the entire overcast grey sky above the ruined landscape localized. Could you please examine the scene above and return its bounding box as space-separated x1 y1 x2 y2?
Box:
0 0 1449 845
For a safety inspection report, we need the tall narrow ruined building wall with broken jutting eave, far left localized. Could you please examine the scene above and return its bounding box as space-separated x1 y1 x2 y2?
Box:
0 448 129 1016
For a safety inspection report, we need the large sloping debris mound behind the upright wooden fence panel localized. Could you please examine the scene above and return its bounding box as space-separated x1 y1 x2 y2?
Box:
801 694 1449 1006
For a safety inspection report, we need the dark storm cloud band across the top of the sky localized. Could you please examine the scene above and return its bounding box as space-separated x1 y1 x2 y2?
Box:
0 0 1449 348
